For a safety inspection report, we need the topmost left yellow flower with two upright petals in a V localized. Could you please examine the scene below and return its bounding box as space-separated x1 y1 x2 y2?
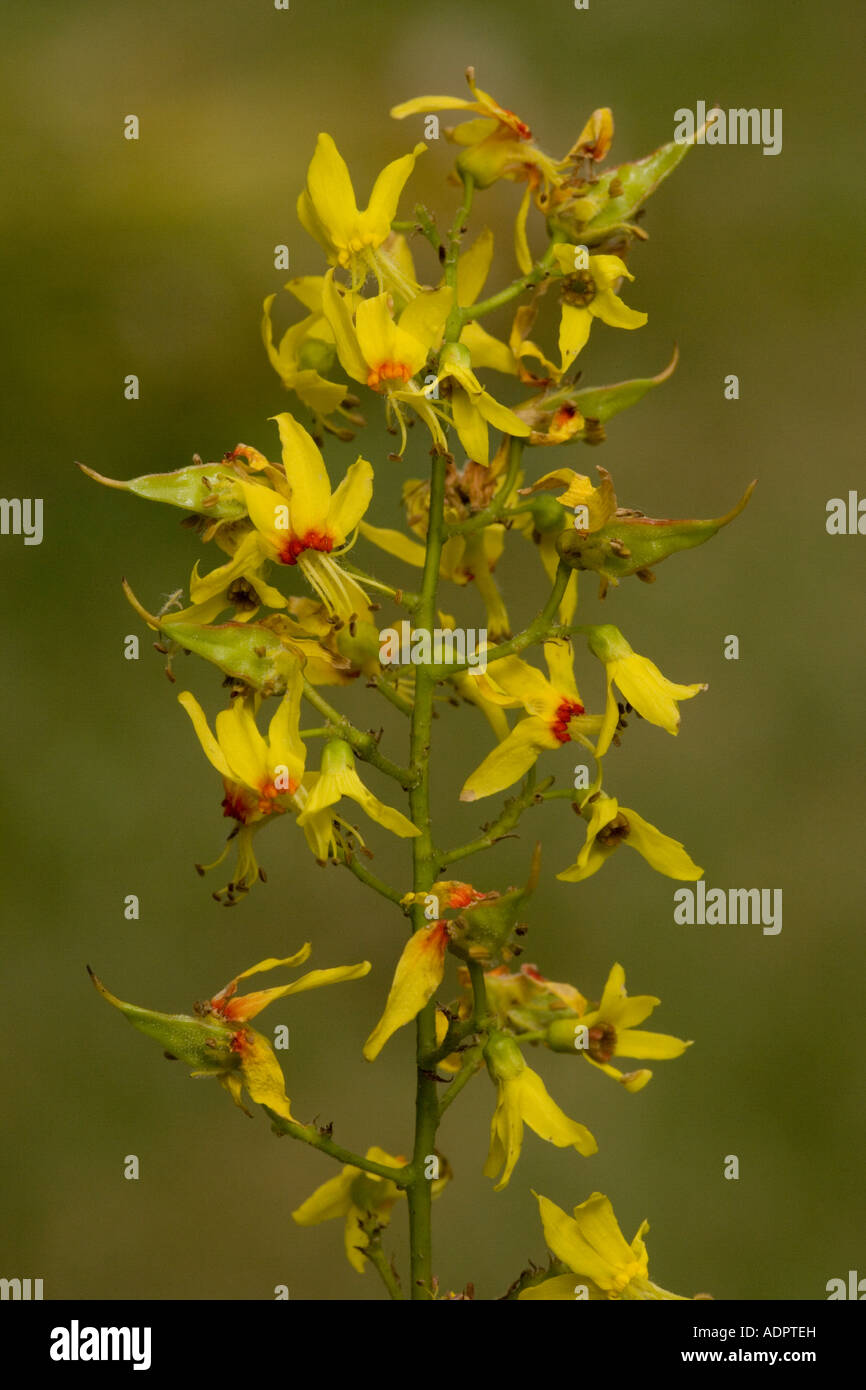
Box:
297 133 427 299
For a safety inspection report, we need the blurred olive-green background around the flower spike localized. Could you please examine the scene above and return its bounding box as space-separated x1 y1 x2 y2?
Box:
0 0 866 1300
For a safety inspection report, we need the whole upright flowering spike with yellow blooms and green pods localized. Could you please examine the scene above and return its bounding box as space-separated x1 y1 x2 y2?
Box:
82 68 753 1300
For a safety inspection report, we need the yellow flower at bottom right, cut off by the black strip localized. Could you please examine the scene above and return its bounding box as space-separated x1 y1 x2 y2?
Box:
517 1193 685 1302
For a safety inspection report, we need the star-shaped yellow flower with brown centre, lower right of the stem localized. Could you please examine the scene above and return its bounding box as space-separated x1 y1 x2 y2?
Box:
545 965 691 1093
